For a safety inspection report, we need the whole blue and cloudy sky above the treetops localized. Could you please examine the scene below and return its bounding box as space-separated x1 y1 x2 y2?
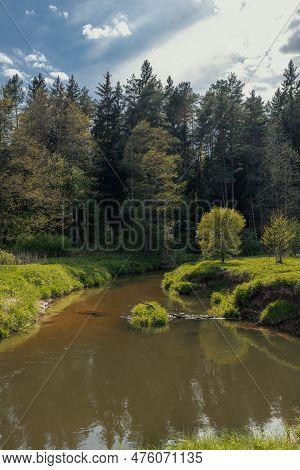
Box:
0 0 300 100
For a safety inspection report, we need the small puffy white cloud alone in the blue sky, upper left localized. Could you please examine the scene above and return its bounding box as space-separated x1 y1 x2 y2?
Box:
82 13 132 39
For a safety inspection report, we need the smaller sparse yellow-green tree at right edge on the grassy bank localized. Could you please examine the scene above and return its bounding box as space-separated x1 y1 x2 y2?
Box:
262 213 298 263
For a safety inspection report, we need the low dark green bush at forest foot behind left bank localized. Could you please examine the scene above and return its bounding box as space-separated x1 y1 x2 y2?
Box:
15 233 71 256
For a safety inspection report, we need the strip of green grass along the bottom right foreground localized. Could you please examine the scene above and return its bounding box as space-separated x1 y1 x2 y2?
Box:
166 432 300 450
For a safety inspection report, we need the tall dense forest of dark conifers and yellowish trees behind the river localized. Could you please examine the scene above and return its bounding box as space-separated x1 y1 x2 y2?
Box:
0 60 300 255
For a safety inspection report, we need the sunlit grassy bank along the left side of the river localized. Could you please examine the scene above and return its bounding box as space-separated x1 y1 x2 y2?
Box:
0 255 161 338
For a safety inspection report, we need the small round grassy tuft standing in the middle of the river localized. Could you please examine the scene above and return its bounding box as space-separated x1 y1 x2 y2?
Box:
130 301 169 329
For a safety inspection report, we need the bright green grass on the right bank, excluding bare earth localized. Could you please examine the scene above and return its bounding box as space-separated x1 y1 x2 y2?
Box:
162 257 300 326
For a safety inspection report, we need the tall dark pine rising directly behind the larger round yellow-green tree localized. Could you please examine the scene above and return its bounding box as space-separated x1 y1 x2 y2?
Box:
197 74 244 206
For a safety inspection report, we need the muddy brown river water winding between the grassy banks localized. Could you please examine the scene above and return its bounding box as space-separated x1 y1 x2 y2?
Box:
0 274 300 449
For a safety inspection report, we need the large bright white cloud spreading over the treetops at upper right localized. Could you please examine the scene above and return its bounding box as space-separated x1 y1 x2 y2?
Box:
112 0 295 99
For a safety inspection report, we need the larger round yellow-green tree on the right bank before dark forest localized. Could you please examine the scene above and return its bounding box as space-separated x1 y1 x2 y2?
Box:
197 207 246 262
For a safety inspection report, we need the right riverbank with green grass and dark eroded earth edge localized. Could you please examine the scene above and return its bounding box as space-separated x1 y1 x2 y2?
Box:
162 257 300 336
